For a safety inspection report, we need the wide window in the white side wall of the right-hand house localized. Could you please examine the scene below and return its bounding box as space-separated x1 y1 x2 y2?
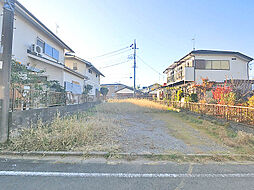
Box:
195 59 229 70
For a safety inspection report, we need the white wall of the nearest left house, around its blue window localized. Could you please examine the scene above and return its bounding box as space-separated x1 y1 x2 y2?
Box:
0 3 65 85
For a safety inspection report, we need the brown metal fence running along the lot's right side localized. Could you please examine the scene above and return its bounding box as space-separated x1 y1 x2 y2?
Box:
155 101 254 125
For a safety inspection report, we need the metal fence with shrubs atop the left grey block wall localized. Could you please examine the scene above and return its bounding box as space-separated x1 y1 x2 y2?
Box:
10 88 93 111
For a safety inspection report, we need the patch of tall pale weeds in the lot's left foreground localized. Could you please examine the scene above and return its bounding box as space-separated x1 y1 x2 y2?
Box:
0 111 121 152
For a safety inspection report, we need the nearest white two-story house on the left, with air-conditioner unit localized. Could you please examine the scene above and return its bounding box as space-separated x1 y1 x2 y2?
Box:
0 1 90 94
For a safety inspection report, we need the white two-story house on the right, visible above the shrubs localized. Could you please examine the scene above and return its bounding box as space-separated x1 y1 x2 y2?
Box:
164 50 253 86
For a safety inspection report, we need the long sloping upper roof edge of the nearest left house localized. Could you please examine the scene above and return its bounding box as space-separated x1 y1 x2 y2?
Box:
15 1 74 53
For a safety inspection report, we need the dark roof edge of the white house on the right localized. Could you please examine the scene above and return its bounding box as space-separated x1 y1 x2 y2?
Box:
163 50 253 73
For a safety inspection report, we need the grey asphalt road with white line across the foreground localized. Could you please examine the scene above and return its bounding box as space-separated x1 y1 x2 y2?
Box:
0 158 254 190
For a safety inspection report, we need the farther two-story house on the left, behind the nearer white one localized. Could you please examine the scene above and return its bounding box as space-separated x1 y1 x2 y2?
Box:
65 54 104 100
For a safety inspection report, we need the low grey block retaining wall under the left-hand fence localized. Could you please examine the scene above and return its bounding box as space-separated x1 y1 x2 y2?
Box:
10 102 99 129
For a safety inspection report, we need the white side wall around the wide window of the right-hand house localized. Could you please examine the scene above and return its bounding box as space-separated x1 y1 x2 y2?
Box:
195 55 248 83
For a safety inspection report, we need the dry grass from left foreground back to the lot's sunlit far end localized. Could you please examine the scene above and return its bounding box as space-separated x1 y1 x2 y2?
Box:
0 99 168 152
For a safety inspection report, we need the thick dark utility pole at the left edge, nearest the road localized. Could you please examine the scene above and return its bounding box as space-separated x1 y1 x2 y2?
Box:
0 0 16 143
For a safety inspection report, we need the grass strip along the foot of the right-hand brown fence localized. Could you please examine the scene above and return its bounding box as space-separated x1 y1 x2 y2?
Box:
174 112 254 154
